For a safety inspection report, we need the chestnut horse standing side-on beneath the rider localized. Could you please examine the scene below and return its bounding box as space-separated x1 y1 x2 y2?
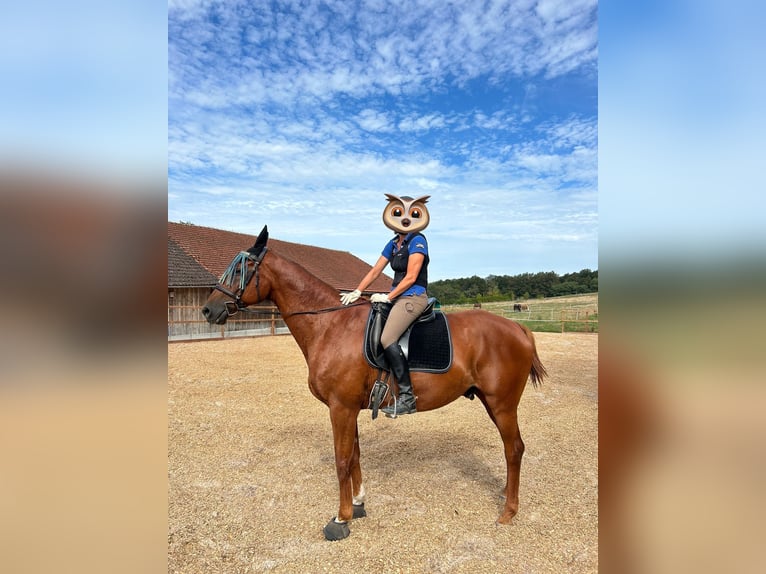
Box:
202 226 547 540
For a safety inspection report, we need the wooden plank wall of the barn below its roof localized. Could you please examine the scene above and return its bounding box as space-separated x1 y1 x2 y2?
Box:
168 287 288 341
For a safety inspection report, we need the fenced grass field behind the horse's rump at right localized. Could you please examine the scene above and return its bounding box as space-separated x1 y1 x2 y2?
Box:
442 293 598 333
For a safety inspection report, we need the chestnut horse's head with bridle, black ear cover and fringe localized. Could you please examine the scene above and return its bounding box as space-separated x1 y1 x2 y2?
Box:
202 225 269 325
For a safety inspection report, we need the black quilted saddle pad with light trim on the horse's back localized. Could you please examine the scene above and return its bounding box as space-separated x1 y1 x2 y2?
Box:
364 311 452 373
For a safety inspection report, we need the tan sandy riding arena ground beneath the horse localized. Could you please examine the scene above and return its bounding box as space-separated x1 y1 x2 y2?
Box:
168 333 598 574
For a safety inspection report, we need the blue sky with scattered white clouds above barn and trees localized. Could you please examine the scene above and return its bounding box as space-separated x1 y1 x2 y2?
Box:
168 0 598 279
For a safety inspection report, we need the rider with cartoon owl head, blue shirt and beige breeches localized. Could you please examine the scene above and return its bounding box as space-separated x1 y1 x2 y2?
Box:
340 193 430 416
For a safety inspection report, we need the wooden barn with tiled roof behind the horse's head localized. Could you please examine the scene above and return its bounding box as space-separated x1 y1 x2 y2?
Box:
168 222 391 341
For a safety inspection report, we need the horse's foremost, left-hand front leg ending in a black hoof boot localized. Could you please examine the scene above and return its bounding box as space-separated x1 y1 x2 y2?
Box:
324 404 363 540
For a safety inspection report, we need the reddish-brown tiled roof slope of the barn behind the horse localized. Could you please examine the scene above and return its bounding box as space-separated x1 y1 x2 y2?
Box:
168 221 391 293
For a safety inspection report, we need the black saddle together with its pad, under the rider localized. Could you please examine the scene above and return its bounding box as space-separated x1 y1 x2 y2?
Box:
364 297 452 373
